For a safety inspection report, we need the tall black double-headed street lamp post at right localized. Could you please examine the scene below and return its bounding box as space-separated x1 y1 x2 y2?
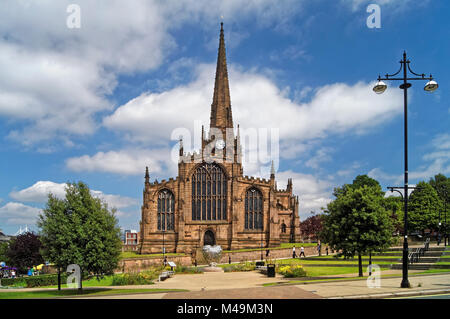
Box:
373 52 438 288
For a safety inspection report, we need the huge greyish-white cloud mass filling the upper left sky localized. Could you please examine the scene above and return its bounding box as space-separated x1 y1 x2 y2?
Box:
0 0 300 151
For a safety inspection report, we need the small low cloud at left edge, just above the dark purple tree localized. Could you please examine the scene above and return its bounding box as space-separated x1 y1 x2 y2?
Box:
0 202 41 225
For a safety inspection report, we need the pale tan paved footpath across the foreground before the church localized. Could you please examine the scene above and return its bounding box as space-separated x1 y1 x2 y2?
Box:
72 271 450 299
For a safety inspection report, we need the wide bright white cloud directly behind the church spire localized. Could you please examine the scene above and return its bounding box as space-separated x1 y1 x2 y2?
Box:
104 65 402 158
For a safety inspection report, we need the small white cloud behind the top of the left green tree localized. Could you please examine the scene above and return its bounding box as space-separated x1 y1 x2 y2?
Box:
9 181 138 209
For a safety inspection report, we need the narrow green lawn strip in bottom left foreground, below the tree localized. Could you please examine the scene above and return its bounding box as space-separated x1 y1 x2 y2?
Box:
0 288 188 299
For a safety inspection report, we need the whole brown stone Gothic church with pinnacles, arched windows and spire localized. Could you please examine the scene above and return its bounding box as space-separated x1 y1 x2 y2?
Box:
139 25 300 253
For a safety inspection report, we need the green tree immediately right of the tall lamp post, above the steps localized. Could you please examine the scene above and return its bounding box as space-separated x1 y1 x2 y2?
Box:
408 181 442 234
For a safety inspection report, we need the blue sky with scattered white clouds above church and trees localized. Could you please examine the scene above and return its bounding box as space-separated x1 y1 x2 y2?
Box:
0 0 450 234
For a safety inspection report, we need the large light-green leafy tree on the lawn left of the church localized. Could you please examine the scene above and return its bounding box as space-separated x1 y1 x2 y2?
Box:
38 182 122 289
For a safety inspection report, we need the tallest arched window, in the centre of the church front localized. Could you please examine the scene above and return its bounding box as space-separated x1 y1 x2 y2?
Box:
192 163 227 220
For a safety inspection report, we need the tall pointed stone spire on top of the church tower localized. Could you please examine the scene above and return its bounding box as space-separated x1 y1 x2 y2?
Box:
210 22 233 138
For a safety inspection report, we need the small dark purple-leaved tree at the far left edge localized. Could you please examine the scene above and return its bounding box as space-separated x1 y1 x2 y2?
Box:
6 232 44 273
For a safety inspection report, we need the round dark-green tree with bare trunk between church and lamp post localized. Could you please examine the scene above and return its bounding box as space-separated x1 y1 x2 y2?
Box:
320 186 393 277
